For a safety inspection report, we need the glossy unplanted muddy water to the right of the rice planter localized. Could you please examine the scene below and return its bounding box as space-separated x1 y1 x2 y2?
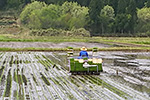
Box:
100 52 150 96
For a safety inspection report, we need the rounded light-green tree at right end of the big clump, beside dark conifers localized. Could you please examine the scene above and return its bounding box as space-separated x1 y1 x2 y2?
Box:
60 2 89 29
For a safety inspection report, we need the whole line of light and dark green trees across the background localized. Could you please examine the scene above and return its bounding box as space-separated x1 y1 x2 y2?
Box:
0 0 150 36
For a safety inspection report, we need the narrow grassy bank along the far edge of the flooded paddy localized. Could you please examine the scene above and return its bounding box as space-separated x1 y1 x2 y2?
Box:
0 47 150 52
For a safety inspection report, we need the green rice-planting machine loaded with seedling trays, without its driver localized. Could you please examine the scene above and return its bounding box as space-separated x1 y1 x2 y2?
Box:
67 47 103 75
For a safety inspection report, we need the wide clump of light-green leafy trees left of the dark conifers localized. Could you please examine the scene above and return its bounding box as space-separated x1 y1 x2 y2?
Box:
20 1 89 30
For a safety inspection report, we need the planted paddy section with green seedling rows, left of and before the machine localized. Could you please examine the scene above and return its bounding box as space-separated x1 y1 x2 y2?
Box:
0 52 149 100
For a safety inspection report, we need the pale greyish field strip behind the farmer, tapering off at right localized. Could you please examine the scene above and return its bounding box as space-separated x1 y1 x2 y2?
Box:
0 42 110 48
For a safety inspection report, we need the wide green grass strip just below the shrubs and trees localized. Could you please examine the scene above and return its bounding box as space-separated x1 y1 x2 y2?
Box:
0 34 150 44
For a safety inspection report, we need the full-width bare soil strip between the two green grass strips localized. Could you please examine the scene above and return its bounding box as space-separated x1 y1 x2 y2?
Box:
0 42 150 48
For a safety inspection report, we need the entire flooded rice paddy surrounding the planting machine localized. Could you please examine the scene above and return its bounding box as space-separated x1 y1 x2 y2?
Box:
0 52 150 100
